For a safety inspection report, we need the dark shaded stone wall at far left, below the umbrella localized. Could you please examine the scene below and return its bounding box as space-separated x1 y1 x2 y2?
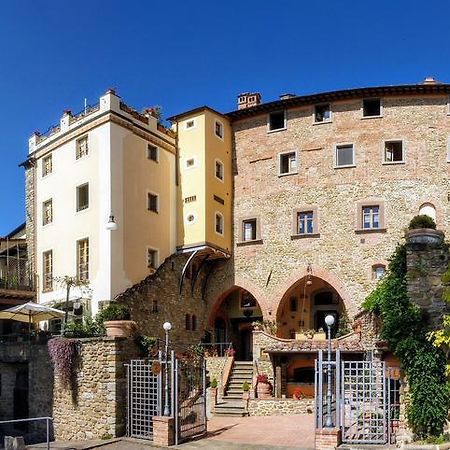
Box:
0 342 53 443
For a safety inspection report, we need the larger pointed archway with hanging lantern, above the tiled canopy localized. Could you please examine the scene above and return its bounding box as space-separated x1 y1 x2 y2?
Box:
277 275 350 339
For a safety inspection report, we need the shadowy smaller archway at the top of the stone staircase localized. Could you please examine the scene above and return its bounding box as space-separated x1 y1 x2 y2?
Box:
211 286 262 361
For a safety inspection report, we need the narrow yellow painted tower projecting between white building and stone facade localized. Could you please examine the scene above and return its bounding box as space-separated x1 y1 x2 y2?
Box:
174 108 232 254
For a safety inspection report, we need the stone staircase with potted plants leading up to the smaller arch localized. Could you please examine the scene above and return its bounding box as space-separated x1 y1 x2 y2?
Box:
214 361 253 417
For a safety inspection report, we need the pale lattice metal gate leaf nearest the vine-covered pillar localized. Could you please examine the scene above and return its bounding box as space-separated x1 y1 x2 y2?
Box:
341 361 389 444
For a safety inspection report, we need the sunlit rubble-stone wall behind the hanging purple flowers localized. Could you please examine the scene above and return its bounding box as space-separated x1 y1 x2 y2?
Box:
53 338 138 440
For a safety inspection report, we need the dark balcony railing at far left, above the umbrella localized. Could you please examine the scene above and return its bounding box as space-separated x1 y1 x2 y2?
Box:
0 256 34 291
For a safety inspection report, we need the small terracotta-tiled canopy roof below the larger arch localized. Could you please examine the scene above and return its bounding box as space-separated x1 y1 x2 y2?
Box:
264 333 365 353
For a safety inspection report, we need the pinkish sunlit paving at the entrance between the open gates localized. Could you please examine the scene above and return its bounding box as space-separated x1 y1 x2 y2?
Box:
30 414 314 450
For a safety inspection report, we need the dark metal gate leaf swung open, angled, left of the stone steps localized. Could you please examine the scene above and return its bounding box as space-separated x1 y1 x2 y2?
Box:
174 356 206 444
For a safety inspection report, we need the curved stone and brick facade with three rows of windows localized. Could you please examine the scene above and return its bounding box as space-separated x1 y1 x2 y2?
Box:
233 95 450 319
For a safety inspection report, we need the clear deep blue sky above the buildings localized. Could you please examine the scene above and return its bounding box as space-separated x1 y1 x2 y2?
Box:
0 0 450 236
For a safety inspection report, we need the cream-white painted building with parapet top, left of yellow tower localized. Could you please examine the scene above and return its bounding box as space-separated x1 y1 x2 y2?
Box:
29 91 176 314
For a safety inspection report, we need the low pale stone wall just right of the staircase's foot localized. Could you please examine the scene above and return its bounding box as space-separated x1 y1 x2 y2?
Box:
248 398 314 416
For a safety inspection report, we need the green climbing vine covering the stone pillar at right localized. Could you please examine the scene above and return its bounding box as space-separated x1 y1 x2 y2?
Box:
363 244 450 438
